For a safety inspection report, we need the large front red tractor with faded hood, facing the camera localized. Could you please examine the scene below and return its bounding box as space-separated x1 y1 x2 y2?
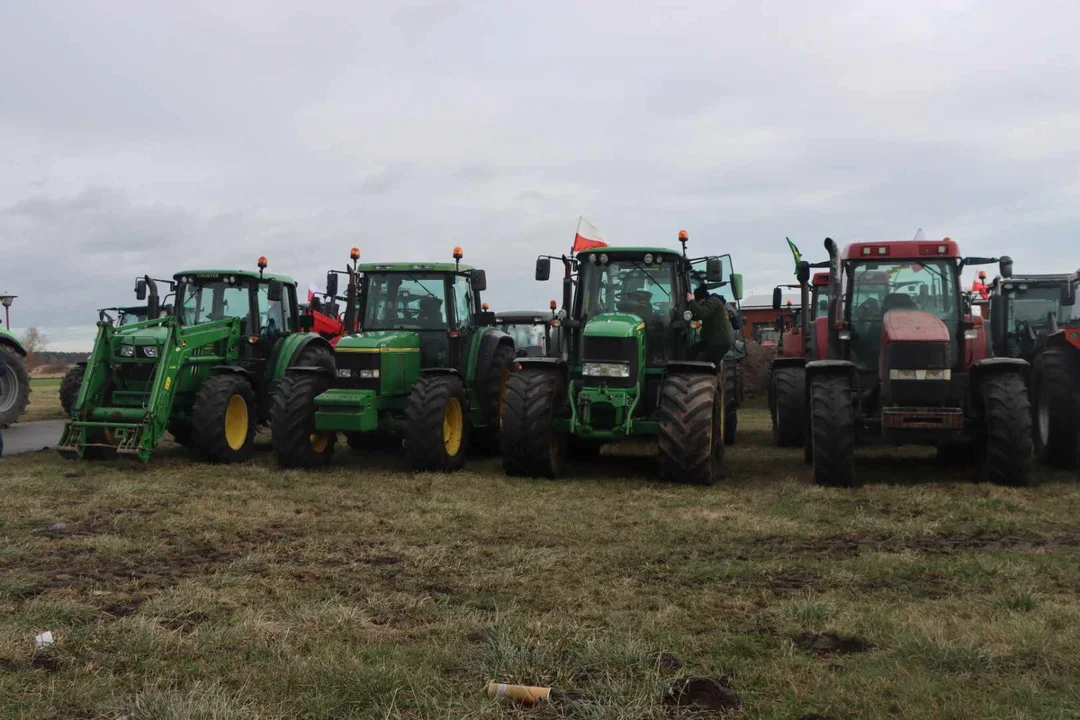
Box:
806 237 1031 486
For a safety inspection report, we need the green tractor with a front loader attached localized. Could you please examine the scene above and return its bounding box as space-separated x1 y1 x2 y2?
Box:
57 258 334 462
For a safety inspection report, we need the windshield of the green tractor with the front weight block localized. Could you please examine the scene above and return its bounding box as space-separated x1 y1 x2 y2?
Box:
362 272 449 330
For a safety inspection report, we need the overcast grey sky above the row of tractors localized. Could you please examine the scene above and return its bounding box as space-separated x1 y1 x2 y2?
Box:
0 0 1080 350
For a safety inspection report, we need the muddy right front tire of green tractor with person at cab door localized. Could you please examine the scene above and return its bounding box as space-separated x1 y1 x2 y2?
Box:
657 373 724 485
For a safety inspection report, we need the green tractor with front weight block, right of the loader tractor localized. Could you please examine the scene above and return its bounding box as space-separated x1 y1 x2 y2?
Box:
271 248 515 472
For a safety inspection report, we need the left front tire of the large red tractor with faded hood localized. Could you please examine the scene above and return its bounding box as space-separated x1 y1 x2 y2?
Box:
809 375 855 488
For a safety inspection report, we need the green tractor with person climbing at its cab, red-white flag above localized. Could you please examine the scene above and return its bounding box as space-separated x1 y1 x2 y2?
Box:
501 233 742 485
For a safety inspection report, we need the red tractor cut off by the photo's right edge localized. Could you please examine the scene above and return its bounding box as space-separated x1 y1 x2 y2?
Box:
1028 271 1080 470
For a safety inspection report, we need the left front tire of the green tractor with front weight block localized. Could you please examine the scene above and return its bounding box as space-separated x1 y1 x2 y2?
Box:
270 372 337 467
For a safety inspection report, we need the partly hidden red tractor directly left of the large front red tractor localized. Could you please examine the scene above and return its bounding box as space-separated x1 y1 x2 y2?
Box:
769 267 829 447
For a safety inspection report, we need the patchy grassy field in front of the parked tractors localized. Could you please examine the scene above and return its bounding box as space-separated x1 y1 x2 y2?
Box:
0 397 1080 720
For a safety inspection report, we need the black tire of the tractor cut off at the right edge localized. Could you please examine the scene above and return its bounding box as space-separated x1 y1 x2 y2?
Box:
1031 348 1080 470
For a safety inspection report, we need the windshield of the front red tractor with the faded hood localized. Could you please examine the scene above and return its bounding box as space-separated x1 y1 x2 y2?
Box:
847 260 960 370
